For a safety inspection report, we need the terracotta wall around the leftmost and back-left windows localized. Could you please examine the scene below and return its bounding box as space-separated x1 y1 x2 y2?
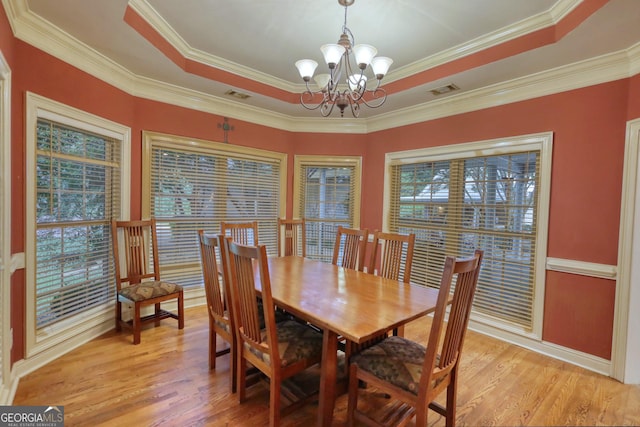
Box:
0 39 295 362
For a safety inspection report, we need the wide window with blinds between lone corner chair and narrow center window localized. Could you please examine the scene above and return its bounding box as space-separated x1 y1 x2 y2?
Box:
143 132 287 287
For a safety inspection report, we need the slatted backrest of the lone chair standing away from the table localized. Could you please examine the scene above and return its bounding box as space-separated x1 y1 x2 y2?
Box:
111 218 160 291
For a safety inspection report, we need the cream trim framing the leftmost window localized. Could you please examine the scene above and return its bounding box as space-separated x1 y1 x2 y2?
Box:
25 92 131 362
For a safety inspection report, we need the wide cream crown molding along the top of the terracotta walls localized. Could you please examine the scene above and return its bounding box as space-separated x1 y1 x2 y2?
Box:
2 0 640 133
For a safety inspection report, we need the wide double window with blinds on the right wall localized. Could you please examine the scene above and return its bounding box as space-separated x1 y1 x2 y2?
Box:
387 137 550 332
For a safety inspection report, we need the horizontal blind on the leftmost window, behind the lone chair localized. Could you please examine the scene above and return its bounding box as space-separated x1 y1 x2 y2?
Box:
35 118 121 329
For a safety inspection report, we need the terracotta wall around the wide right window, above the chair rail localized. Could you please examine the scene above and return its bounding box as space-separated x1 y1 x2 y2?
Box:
363 80 628 265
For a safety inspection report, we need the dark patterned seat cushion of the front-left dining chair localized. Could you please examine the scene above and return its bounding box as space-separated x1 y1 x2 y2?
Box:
245 320 322 367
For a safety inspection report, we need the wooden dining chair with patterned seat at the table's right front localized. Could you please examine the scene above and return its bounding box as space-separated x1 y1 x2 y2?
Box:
347 250 483 427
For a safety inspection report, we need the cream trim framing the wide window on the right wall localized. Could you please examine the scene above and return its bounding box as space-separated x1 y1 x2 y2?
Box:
382 132 553 341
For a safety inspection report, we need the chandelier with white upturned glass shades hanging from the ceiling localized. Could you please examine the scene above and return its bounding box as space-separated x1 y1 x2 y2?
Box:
296 0 393 117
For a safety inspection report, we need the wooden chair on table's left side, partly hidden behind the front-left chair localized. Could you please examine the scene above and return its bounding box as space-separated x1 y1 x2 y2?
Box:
198 230 237 393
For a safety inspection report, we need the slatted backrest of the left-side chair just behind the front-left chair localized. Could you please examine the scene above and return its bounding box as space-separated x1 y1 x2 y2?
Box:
198 230 228 321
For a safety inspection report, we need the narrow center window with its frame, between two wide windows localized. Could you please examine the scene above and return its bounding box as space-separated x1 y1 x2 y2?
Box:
293 156 361 262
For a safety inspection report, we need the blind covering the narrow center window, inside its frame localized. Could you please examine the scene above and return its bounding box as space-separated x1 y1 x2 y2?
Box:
299 164 359 262
